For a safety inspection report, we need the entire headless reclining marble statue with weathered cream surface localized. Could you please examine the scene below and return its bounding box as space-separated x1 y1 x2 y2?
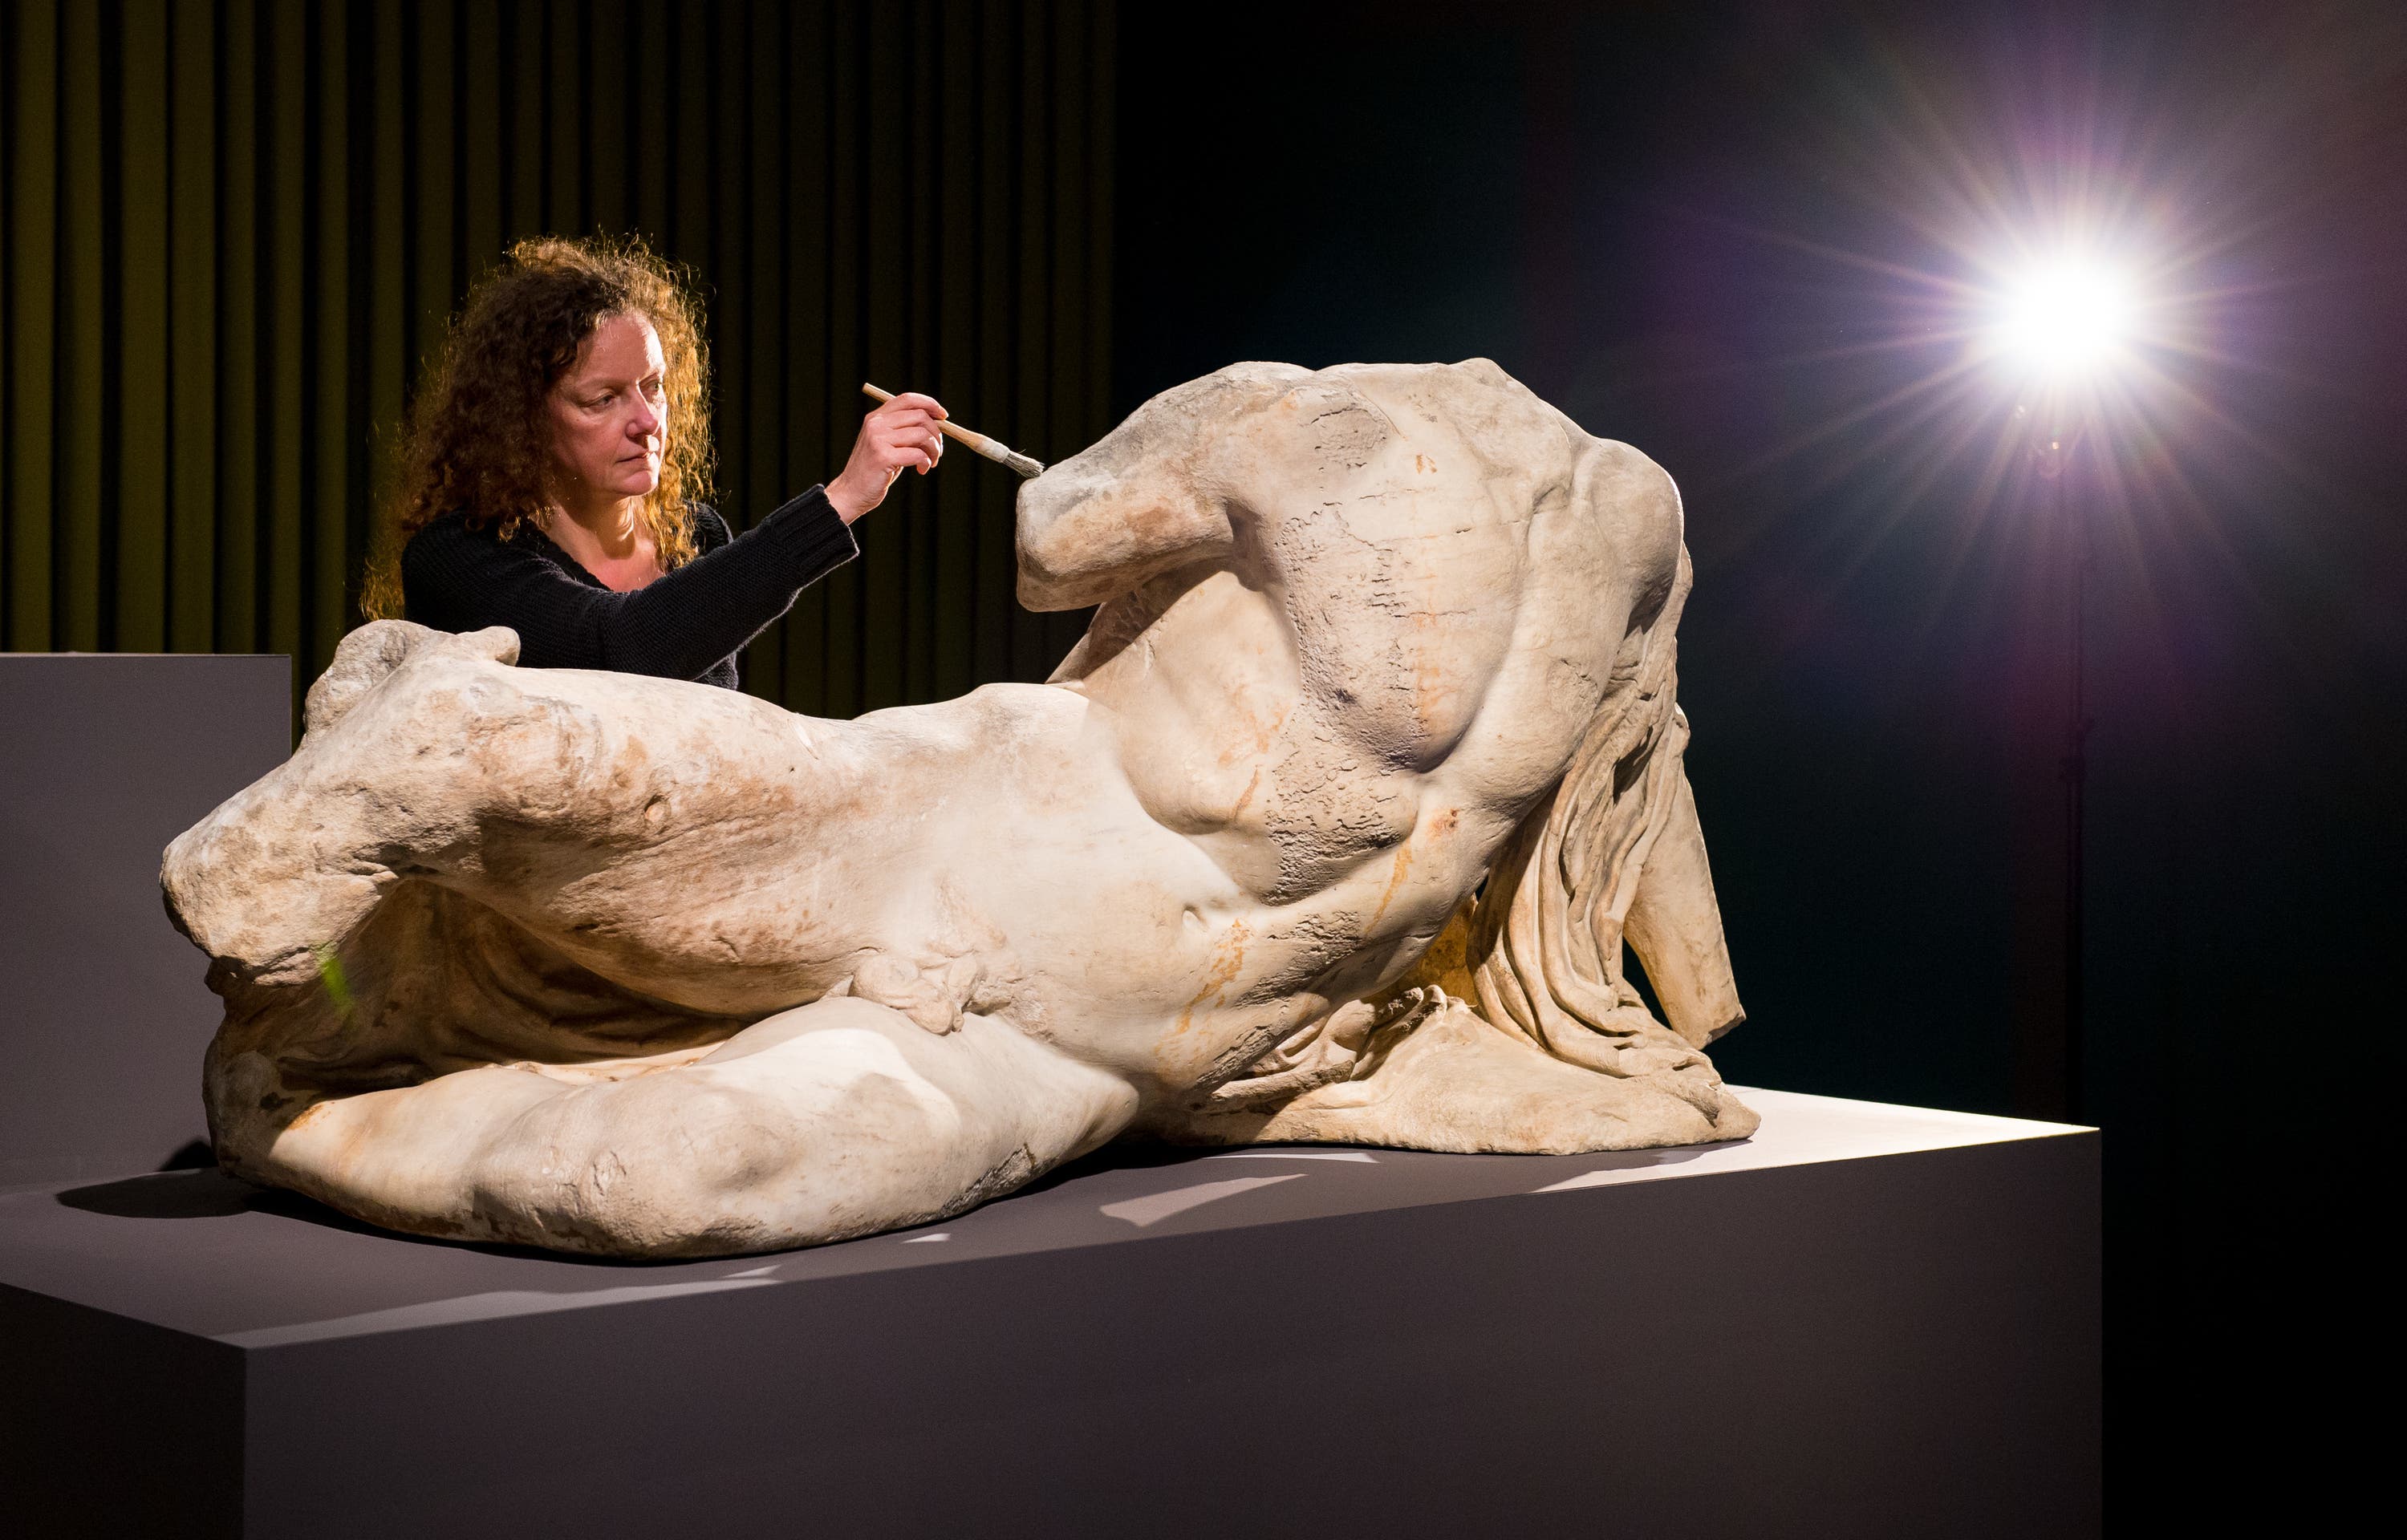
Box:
161 361 1755 1256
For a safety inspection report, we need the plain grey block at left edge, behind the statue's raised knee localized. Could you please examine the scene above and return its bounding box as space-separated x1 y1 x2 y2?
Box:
0 652 291 1186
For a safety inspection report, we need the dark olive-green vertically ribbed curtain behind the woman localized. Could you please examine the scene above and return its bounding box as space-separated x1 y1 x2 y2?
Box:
0 0 1112 715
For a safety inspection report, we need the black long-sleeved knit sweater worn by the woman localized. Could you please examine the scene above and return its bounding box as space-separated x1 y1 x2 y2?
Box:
402 486 859 691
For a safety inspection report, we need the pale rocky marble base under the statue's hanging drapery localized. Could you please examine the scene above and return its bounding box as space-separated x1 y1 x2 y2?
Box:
1148 1001 1757 1155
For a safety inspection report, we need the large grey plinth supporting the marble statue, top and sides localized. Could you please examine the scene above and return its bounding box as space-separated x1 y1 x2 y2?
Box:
0 1092 2099 1540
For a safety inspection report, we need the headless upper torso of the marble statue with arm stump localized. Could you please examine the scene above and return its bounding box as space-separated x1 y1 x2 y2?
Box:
1021 363 1680 1080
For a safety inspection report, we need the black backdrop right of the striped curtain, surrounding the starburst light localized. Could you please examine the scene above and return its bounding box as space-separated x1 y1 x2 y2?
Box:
1114 2 2407 1494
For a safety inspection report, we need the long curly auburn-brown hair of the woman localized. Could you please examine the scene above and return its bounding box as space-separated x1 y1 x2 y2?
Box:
359 236 710 618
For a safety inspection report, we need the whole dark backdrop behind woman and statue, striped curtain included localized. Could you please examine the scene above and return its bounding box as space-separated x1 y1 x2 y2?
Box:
0 0 2407 1480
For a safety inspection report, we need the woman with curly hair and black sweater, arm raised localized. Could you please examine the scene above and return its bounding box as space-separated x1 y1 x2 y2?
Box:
361 238 944 688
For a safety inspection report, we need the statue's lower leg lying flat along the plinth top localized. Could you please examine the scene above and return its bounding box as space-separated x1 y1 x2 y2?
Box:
231 999 1136 1256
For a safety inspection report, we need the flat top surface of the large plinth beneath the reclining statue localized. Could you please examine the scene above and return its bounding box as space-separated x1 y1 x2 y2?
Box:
0 1090 2075 1348
